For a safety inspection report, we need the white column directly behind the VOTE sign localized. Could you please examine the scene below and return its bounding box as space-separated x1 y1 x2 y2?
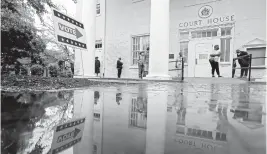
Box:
74 0 96 78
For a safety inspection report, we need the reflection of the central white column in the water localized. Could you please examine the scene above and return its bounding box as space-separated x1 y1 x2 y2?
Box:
146 91 168 154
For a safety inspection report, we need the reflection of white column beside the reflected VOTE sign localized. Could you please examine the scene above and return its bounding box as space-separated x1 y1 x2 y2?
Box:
73 90 94 154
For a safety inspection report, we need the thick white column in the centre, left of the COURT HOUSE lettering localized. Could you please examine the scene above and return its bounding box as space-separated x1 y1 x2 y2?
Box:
146 0 171 80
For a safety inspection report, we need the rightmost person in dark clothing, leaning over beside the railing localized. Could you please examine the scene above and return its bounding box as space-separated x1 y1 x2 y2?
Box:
236 50 249 78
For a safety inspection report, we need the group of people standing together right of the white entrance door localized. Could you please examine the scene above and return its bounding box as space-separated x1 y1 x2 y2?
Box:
209 45 249 78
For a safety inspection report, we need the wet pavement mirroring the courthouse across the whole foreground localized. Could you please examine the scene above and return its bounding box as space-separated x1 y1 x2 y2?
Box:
1 83 266 154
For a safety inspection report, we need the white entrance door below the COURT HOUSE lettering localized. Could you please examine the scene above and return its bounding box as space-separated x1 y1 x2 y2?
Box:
195 39 220 77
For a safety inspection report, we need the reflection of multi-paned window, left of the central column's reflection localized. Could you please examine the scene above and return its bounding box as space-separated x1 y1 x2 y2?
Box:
129 97 147 129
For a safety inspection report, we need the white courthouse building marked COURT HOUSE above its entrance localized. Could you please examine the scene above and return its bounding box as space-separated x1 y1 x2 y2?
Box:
77 0 266 78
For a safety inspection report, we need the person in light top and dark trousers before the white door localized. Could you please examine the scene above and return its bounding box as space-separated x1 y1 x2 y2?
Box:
209 45 222 77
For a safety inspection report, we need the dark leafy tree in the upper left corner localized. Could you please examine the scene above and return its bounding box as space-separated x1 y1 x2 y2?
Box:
1 0 56 70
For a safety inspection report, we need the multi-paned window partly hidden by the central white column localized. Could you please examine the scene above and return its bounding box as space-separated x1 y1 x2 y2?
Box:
132 35 149 65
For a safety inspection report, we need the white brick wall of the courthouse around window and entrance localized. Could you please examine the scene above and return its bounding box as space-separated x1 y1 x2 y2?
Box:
105 0 266 78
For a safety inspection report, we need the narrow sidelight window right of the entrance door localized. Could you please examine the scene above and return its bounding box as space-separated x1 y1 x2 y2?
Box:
220 38 231 62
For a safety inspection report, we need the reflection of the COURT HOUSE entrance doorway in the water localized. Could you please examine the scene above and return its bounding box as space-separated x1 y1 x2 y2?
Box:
176 92 230 142
